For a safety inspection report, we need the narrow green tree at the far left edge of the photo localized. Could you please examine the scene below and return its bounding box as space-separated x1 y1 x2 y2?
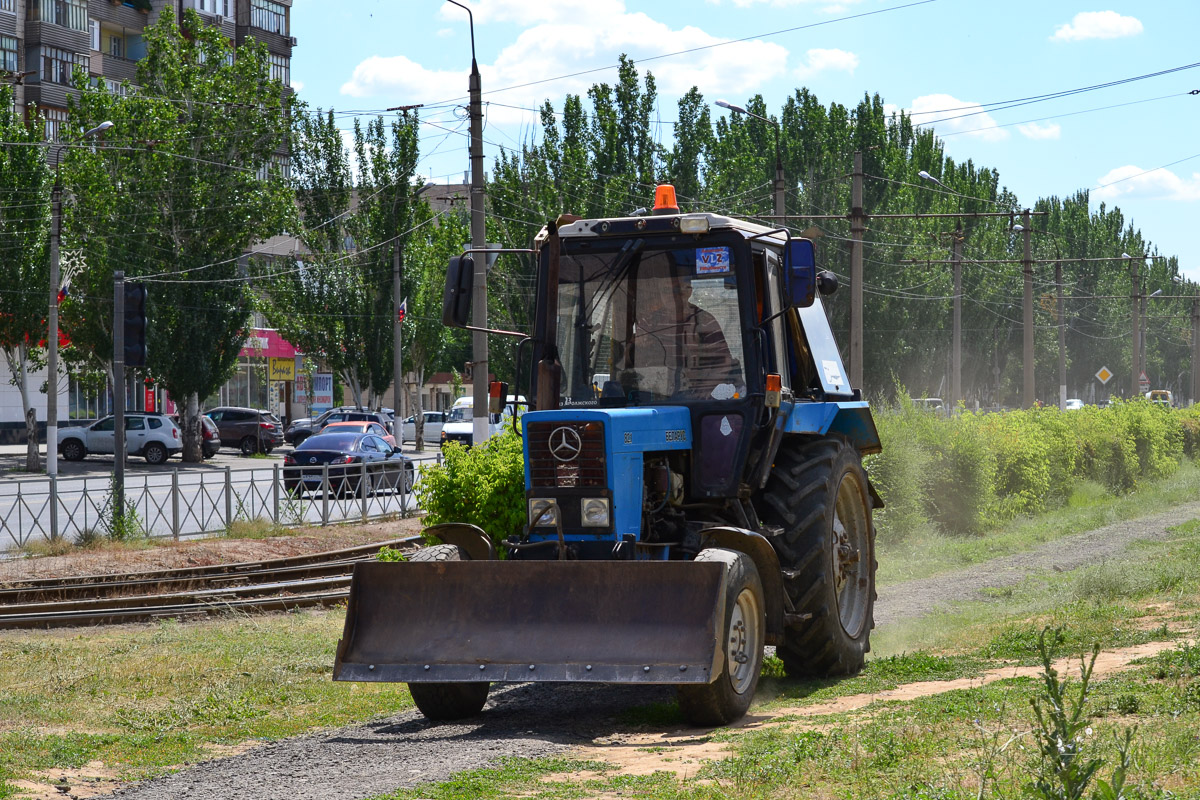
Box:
0 84 51 473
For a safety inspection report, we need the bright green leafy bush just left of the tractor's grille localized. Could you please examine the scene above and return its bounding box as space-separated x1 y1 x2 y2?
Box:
415 428 526 551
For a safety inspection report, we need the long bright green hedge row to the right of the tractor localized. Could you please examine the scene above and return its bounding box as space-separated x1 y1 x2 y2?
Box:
866 397 1200 536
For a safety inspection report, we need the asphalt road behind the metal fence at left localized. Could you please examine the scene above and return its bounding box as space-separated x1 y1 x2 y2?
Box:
0 447 438 551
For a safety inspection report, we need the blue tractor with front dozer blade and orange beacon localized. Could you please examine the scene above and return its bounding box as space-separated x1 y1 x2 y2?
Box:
334 187 882 726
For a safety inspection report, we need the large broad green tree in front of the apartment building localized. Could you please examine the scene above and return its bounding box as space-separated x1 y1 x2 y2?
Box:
65 6 294 462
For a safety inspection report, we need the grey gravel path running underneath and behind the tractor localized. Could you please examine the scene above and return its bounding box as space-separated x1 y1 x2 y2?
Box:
103 503 1200 800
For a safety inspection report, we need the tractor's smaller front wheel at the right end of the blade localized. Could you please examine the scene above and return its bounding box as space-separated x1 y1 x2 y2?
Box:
678 547 767 727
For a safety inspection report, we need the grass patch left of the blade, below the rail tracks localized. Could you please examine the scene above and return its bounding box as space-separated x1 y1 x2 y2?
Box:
0 610 412 796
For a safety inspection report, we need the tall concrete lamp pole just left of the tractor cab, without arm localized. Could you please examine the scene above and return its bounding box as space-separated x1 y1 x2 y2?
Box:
470 54 490 444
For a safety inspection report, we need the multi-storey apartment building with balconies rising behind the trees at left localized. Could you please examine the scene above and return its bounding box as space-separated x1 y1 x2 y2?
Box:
0 0 296 138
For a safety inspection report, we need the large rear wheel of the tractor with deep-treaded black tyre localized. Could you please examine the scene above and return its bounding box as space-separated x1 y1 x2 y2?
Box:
757 438 876 678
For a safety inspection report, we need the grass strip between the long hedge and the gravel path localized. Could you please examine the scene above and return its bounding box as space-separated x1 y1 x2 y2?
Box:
877 459 1200 585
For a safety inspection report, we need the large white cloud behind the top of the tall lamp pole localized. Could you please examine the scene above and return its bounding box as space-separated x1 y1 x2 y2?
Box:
341 0 787 124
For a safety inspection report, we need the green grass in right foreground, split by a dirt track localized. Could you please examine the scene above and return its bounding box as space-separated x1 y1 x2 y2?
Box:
355 521 1200 800
